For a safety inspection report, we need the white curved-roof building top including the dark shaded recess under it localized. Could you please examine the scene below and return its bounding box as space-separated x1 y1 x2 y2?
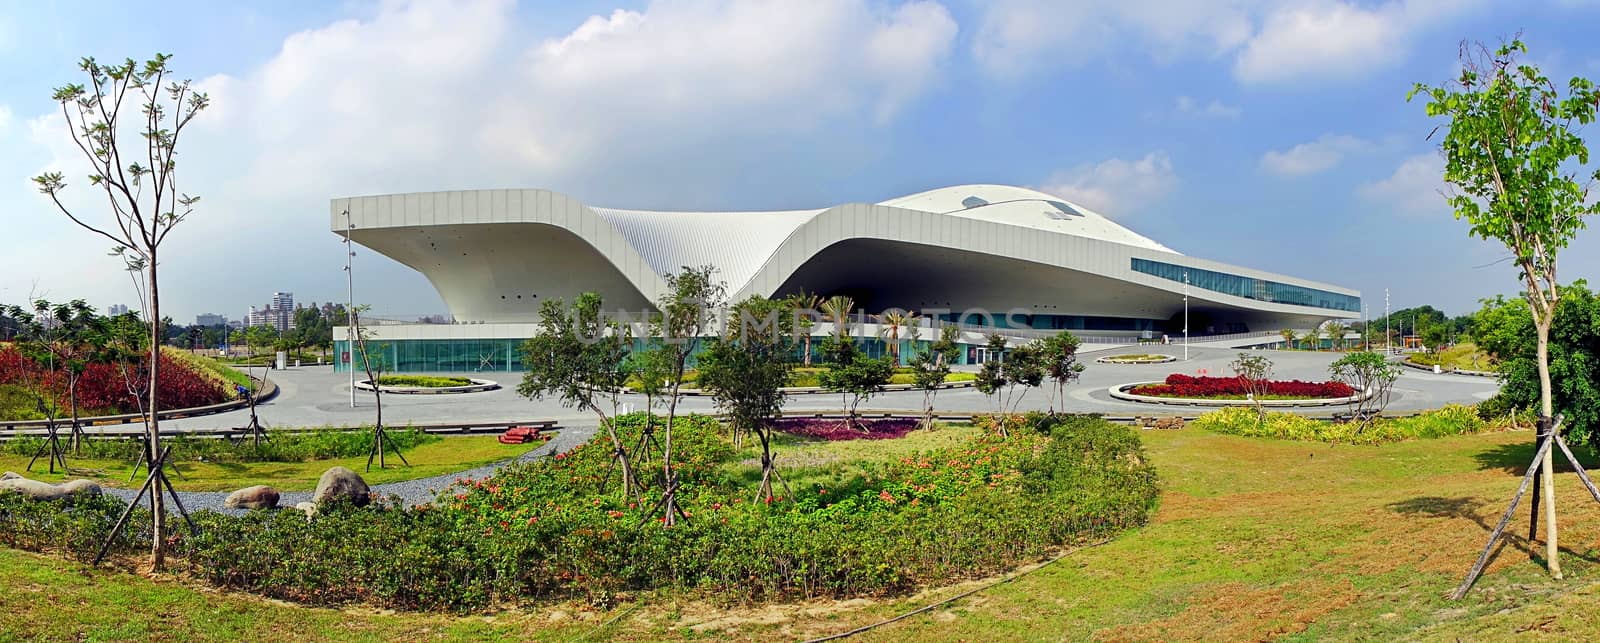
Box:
330 186 1362 361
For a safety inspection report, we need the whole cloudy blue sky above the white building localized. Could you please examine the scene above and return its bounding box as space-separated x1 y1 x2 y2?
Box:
0 0 1600 322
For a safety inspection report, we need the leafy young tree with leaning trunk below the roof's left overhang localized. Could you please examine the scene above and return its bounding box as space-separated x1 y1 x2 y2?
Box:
517 293 640 501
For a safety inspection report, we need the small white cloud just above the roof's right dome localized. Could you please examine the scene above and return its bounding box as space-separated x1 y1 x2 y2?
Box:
1037 152 1178 216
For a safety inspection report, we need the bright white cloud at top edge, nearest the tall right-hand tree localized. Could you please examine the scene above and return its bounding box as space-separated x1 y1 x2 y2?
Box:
1234 0 1477 83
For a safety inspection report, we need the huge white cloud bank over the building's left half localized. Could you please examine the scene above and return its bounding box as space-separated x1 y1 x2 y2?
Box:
9 0 957 315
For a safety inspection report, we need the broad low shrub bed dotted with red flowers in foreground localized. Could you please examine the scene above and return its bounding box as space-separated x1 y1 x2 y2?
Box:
144 416 1157 609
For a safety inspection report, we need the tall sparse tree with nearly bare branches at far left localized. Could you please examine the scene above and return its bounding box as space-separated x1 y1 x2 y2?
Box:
34 54 210 569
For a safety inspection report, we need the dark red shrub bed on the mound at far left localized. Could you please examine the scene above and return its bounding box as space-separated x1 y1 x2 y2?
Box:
0 347 229 413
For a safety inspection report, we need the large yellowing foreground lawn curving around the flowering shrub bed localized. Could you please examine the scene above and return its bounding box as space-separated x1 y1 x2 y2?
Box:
9 429 1600 641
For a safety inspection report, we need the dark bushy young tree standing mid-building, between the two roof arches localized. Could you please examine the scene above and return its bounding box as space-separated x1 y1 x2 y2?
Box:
699 296 794 501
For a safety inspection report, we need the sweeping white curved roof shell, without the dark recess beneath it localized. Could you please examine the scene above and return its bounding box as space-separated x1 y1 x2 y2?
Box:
330 186 1360 322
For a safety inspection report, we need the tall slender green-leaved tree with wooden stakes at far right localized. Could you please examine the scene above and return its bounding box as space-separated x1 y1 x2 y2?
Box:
1406 40 1600 577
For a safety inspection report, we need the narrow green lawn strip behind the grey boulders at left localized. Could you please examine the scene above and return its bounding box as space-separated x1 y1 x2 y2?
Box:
0 433 539 491
